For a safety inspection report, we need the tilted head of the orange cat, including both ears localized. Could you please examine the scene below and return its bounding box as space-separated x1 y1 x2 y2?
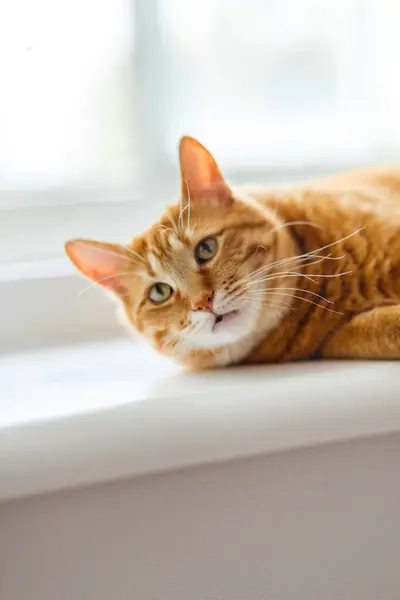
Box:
66 137 291 367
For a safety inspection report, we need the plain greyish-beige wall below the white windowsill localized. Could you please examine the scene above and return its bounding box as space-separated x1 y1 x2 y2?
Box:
0 435 400 600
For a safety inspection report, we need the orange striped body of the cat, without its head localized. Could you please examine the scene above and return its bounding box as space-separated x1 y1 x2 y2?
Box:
247 166 400 362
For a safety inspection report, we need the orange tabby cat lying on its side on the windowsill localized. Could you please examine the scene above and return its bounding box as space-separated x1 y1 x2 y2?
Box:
66 137 400 368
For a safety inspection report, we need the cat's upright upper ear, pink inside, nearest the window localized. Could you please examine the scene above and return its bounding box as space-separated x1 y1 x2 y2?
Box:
179 136 232 206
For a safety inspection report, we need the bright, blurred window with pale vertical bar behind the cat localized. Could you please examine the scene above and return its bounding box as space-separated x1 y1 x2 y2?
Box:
0 0 400 204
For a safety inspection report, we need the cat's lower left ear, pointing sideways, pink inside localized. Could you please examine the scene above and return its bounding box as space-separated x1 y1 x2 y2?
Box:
65 240 133 295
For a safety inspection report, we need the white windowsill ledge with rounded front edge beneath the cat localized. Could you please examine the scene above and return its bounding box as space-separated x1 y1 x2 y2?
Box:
0 340 400 499
